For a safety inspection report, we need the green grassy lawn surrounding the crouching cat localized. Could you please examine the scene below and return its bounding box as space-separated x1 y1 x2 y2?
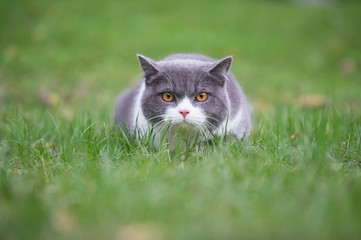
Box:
0 0 361 240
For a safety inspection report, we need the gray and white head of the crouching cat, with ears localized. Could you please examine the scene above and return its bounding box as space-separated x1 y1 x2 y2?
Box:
138 55 232 133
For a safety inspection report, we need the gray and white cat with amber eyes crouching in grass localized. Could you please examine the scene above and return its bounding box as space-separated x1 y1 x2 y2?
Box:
116 54 252 146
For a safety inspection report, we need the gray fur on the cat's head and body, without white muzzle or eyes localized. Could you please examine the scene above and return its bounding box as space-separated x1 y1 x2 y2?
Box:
116 54 252 138
